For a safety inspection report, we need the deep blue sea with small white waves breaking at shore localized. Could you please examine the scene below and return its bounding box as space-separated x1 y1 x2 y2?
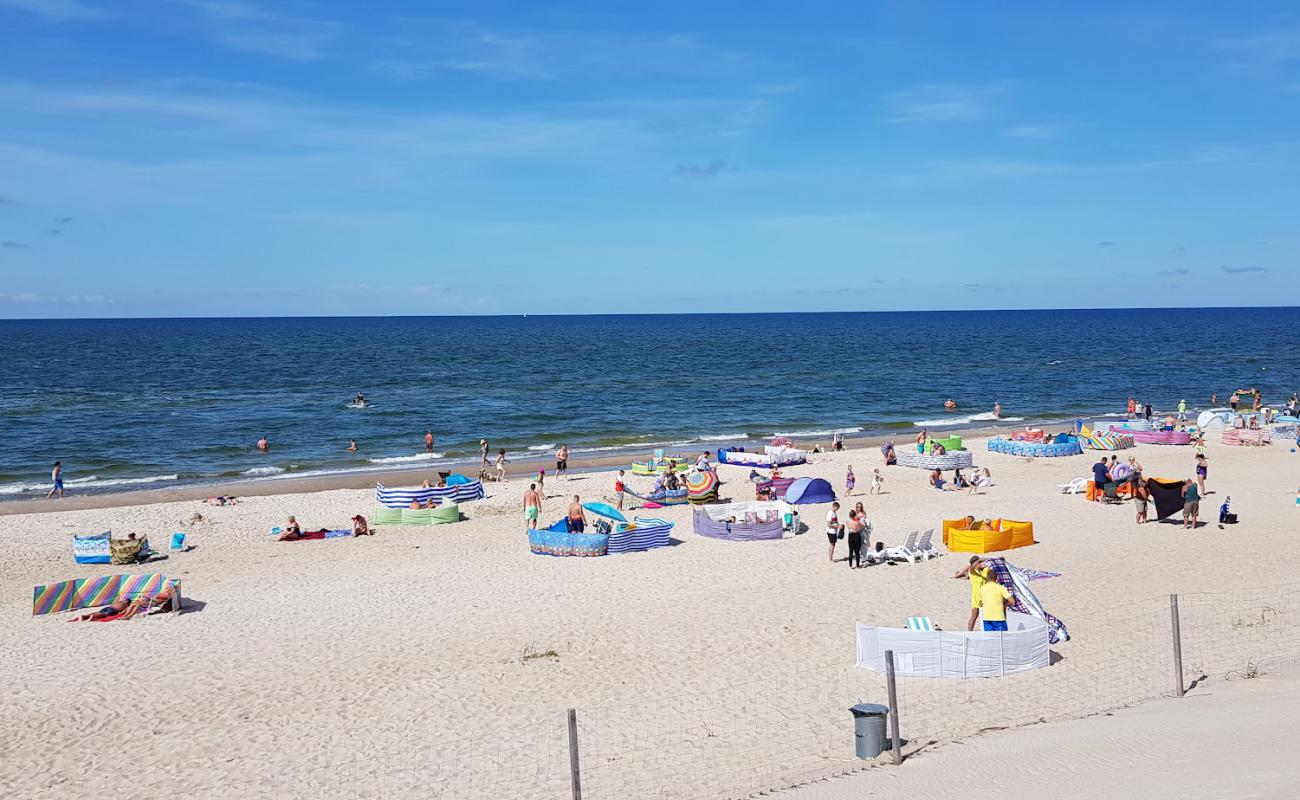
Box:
0 308 1300 500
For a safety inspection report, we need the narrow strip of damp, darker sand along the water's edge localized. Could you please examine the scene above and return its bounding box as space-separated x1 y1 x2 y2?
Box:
0 418 1050 516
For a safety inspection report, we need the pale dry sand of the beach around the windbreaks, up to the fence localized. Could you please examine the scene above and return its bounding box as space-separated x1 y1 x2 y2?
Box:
0 434 1300 797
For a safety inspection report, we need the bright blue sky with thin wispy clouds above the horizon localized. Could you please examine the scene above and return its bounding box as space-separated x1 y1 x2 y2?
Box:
0 0 1300 317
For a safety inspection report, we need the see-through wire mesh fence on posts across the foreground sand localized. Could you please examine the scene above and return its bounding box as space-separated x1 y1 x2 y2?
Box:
98 585 1300 800
